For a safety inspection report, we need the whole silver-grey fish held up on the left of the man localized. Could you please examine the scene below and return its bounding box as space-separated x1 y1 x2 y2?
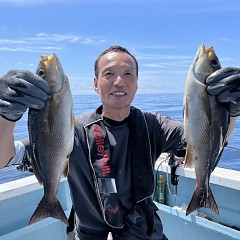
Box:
28 54 74 225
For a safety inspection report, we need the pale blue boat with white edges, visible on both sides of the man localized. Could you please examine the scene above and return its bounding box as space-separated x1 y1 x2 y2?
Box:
0 154 240 240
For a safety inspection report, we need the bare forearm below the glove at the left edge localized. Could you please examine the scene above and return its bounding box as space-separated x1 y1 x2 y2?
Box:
0 116 15 168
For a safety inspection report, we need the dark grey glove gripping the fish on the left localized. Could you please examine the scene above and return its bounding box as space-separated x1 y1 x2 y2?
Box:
0 70 50 122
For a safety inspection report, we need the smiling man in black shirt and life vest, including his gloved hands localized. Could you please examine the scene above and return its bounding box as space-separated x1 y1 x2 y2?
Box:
0 46 240 240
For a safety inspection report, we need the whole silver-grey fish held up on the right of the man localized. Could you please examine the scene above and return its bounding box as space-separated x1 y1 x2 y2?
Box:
184 45 229 215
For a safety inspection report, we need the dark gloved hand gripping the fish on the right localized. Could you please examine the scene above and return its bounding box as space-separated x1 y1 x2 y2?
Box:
206 67 240 117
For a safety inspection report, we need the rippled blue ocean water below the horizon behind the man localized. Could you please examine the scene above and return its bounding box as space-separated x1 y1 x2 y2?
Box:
0 93 240 183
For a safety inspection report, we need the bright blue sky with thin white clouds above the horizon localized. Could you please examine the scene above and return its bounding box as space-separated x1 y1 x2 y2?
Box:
0 0 240 94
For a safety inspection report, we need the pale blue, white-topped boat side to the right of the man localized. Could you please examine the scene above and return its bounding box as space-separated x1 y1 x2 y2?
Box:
155 154 240 240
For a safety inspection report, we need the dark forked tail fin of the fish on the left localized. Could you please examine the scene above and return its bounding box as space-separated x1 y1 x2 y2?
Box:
28 197 68 225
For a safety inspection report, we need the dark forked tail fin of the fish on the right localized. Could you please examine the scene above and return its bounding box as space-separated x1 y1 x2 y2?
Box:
186 187 219 215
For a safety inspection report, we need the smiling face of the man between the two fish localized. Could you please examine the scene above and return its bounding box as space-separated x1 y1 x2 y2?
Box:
94 52 137 109
